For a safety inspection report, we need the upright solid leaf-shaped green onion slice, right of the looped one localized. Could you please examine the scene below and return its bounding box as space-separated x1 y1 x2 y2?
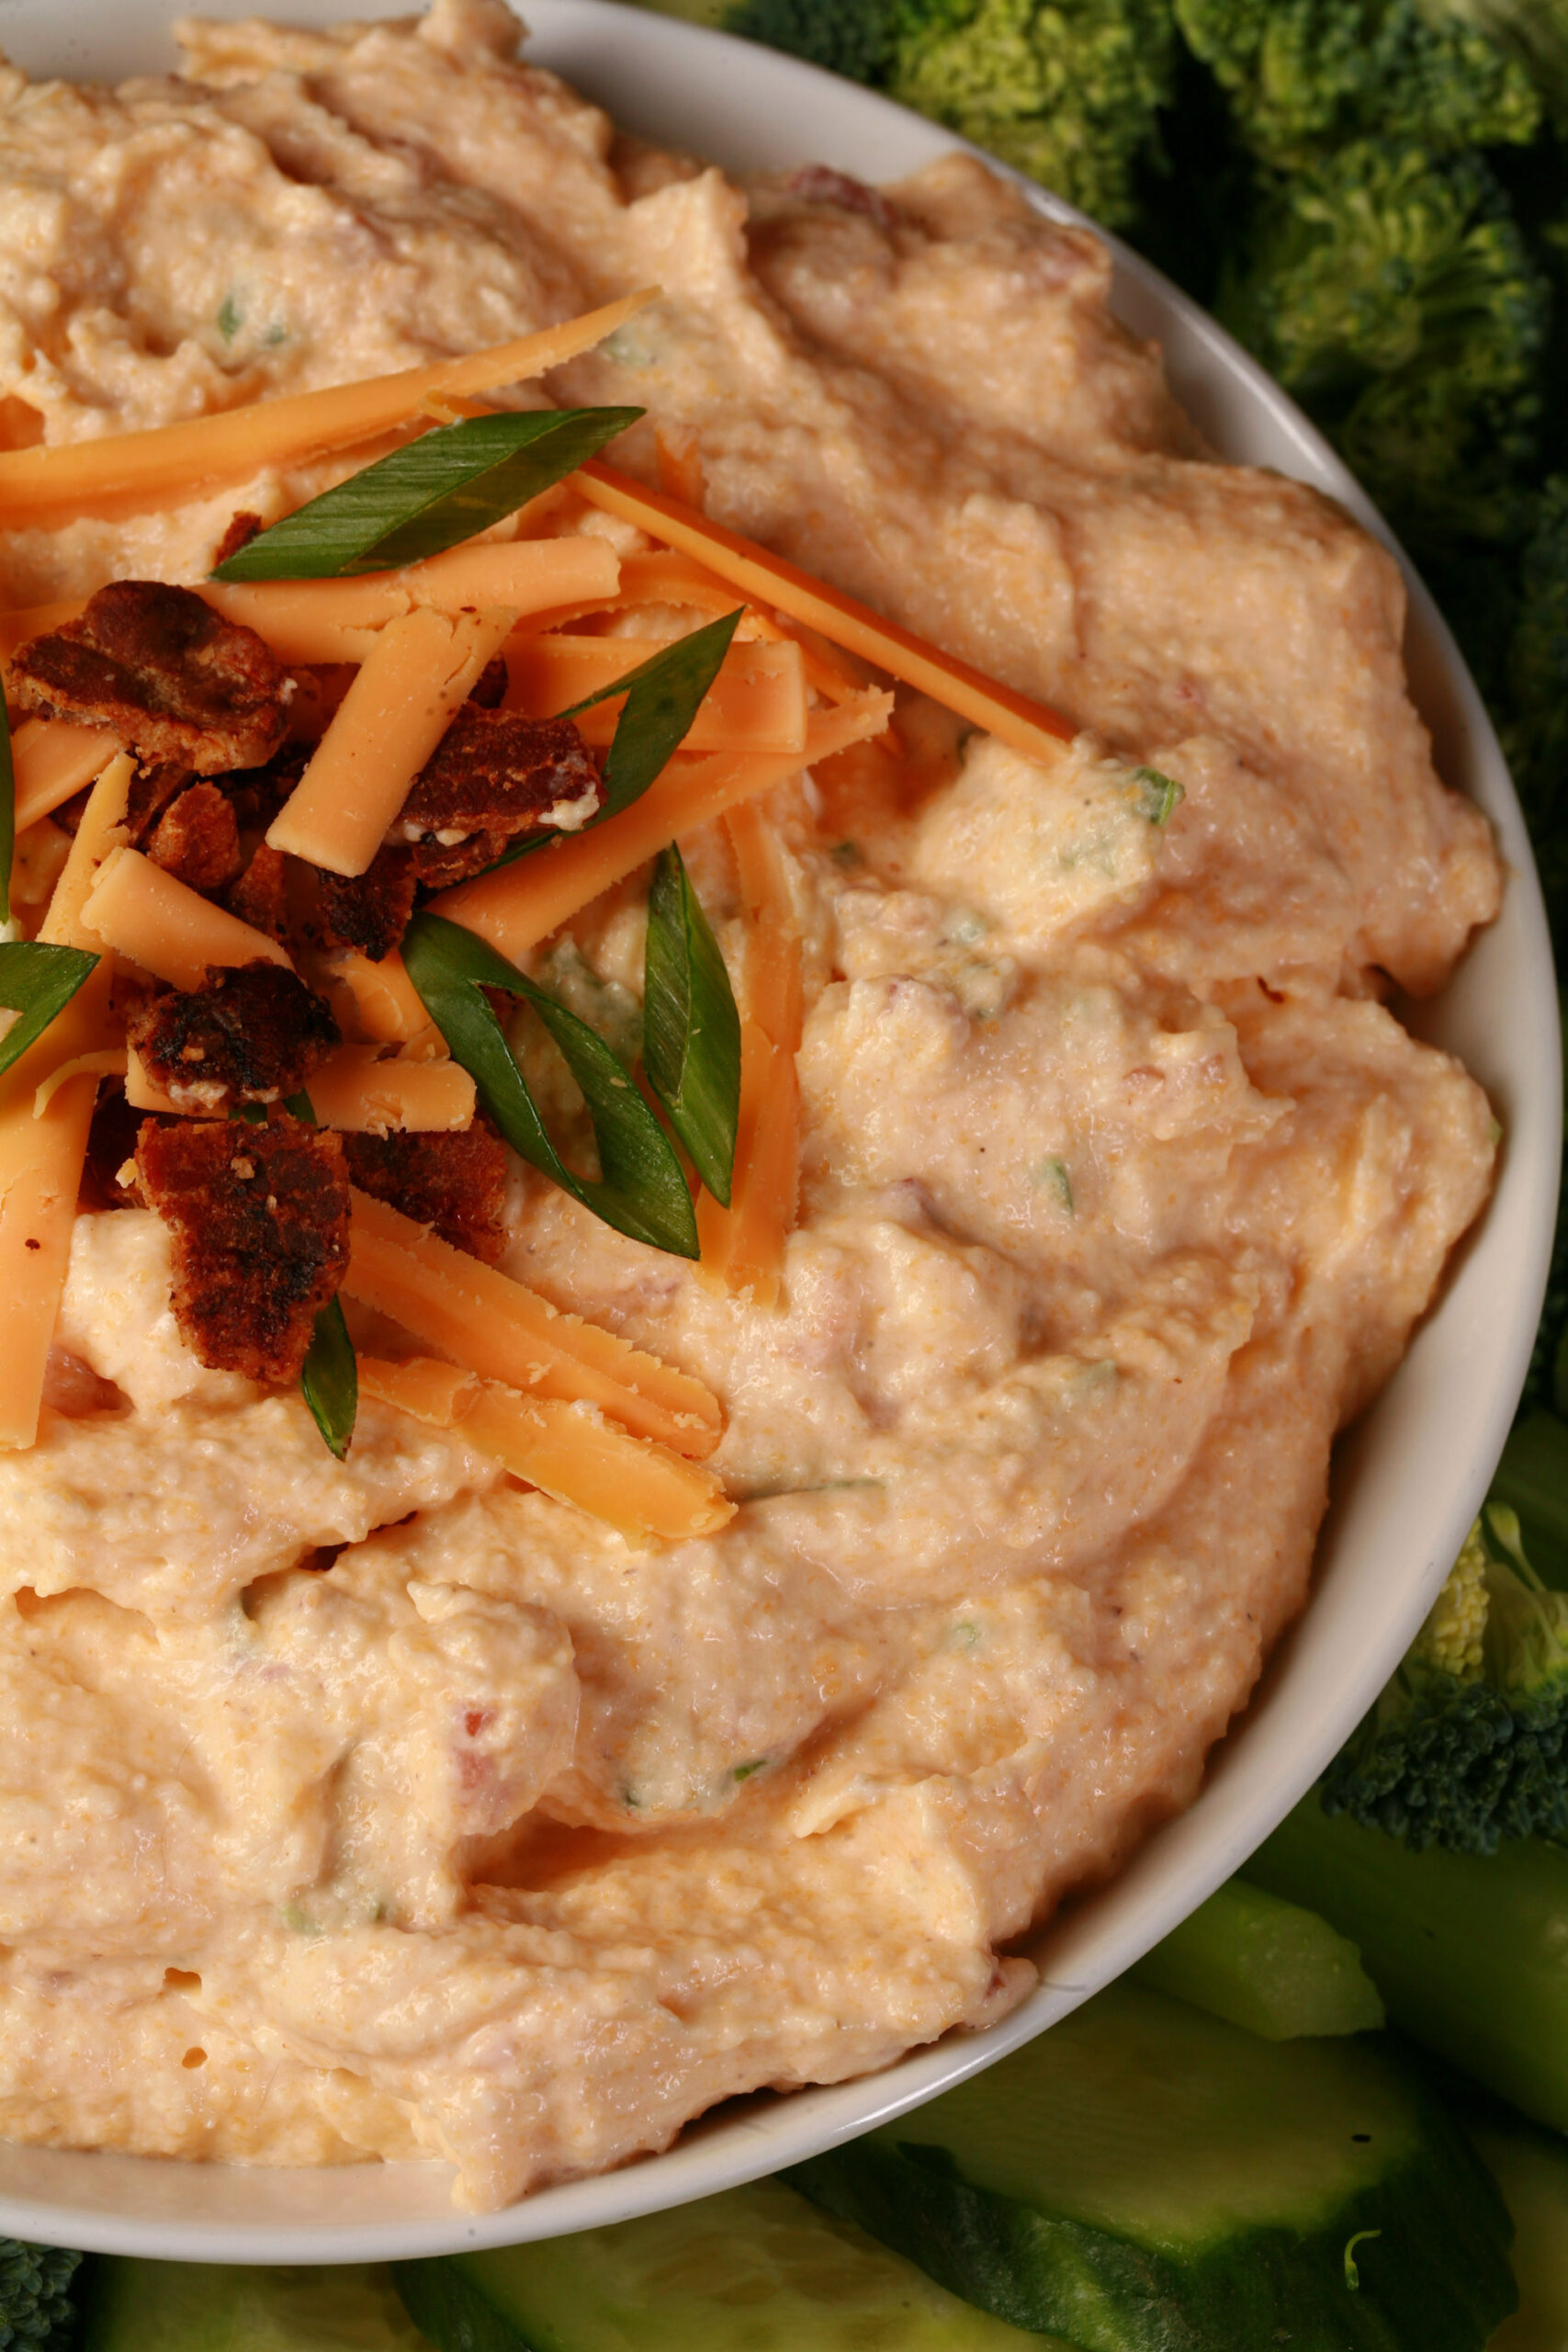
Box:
642 844 740 1209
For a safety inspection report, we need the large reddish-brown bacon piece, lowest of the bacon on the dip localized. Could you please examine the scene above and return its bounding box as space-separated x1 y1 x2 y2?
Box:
136 1113 348 1383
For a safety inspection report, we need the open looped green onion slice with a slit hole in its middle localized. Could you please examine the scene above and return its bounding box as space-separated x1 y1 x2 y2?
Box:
402 915 698 1259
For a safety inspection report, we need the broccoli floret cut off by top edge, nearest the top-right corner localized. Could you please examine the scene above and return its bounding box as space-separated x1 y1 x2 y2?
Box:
1176 0 1547 164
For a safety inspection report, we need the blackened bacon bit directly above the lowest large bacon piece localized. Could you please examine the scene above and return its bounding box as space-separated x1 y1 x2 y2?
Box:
125 959 344 1113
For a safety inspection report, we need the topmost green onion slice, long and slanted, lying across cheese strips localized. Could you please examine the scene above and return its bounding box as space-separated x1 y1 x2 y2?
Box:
211 409 642 581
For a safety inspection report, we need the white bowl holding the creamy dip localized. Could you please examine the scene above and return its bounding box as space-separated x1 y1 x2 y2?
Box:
0 0 1563 2263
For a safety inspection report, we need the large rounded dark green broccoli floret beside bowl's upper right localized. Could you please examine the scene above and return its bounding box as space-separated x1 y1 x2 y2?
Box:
1218 139 1550 548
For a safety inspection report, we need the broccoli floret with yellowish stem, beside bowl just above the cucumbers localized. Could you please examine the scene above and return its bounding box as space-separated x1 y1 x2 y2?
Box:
1324 1503 1568 1853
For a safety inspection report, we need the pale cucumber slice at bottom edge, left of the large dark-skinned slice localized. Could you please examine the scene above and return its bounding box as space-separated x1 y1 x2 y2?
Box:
392 2180 1072 2352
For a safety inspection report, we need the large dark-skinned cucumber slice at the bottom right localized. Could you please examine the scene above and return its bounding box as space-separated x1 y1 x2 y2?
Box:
785 1983 1518 2352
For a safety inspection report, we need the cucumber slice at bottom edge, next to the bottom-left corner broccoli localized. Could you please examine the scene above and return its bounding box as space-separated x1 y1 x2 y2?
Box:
80 2256 430 2352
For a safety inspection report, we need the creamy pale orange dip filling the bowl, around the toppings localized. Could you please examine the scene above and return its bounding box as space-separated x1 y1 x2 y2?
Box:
0 0 1500 2206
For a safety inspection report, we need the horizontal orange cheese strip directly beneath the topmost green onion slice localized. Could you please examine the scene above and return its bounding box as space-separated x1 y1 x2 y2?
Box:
197 538 621 661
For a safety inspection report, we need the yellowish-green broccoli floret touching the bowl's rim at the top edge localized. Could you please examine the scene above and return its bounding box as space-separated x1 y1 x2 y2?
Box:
888 0 1176 228
